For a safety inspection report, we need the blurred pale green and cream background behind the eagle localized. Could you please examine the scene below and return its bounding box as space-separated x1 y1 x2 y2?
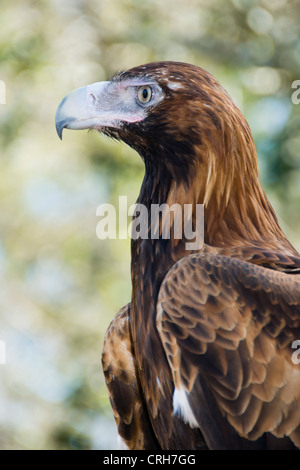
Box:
0 0 300 449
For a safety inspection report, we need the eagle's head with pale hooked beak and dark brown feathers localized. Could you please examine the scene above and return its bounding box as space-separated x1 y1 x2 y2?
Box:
56 62 252 185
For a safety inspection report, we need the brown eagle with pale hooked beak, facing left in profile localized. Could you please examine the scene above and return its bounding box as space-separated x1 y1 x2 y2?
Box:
56 61 300 450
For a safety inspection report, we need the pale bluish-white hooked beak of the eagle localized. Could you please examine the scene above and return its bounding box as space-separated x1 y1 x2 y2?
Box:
55 82 112 139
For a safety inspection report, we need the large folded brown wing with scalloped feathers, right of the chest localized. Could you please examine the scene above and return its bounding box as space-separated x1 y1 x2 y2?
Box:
157 254 300 448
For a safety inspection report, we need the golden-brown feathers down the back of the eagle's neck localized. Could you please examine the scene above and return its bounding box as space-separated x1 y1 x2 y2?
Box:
167 90 295 253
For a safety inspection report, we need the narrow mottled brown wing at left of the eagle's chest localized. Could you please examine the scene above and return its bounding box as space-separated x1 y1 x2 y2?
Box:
102 304 159 450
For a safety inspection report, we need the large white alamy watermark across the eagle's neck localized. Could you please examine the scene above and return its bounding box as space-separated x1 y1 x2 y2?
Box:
96 196 204 250
